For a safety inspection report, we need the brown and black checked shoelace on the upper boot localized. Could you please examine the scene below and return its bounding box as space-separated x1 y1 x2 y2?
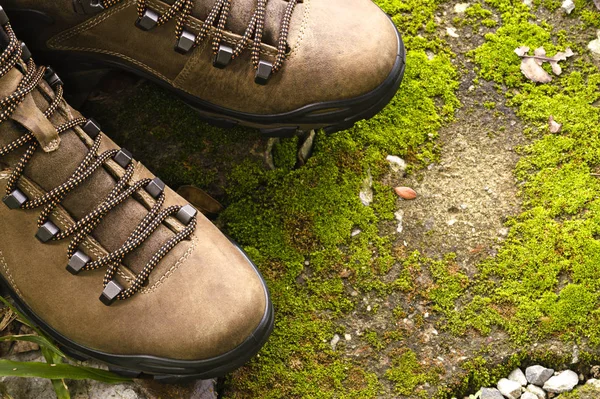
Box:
101 0 302 84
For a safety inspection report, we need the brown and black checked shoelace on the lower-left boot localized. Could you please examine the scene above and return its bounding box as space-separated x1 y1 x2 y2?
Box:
0 18 197 305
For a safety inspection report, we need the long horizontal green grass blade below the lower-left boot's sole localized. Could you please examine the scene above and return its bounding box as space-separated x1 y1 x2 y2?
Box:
0 359 131 384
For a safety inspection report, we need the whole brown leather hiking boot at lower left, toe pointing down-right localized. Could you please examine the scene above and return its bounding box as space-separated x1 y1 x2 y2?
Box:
0 7 273 382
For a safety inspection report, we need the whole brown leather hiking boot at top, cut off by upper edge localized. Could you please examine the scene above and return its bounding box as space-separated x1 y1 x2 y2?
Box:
3 0 405 136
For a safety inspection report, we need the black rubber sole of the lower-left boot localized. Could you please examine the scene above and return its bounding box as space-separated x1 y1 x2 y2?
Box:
0 247 275 383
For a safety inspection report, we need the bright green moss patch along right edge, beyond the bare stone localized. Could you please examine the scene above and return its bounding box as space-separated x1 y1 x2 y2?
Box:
445 0 600 354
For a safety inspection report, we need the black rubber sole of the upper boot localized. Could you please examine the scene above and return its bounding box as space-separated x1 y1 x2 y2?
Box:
9 10 406 137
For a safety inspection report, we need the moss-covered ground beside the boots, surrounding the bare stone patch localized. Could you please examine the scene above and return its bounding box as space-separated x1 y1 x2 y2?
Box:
76 0 600 398
